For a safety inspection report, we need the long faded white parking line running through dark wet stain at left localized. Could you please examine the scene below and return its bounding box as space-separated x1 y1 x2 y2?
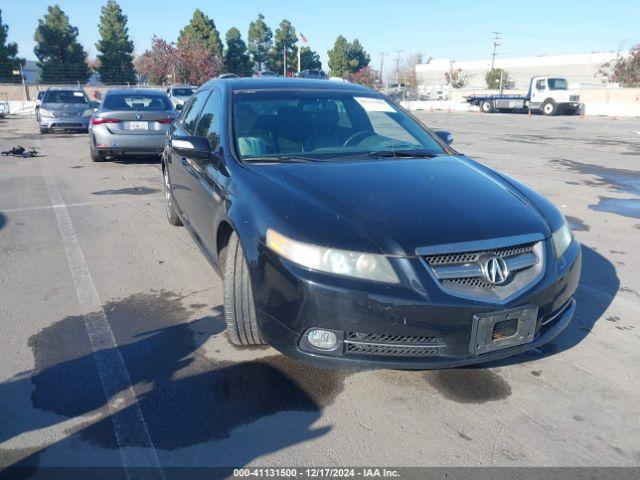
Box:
40 159 164 479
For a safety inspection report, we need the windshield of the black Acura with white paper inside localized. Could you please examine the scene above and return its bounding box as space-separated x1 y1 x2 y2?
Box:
234 90 444 161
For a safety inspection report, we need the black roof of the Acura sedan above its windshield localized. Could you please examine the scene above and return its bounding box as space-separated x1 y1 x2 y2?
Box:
200 77 370 93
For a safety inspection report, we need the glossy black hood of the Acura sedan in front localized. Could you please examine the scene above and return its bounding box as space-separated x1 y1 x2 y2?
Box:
248 156 550 255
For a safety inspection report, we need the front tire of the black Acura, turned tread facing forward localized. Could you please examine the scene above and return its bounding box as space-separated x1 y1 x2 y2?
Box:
225 233 265 346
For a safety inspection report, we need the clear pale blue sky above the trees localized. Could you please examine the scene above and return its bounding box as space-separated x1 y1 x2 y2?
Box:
0 0 640 76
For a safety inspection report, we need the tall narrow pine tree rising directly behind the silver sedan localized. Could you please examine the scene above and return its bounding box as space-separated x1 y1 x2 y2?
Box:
96 0 136 84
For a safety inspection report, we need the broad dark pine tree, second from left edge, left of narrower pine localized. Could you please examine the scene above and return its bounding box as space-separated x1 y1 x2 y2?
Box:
34 5 91 83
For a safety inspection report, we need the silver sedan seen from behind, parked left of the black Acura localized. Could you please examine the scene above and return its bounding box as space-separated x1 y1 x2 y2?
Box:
89 89 176 162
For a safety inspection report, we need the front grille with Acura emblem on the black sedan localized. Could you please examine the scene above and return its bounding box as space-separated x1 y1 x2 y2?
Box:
423 237 544 301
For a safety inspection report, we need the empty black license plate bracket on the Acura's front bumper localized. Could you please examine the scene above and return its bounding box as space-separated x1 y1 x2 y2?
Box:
469 305 538 355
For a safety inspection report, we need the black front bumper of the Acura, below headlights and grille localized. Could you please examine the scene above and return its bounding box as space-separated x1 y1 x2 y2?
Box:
254 242 581 369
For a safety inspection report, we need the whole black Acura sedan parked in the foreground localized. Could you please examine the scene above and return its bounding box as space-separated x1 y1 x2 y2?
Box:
162 79 581 369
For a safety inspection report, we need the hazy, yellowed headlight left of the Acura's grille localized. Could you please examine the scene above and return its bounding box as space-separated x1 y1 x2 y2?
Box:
267 229 399 283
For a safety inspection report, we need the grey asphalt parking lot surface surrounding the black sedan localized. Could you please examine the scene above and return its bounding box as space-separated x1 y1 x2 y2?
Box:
0 112 640 467
